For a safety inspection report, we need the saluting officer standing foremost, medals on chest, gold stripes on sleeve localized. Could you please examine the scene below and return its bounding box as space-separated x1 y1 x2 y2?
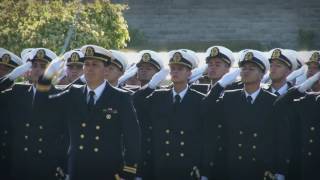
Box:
38 45 140 180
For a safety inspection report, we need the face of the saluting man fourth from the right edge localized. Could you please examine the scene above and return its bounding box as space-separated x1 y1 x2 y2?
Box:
208 58 230 80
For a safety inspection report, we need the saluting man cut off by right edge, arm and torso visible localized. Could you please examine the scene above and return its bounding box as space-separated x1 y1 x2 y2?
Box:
276 69 320 180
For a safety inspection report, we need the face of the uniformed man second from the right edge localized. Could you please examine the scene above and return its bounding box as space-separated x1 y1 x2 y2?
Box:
270 59 291 82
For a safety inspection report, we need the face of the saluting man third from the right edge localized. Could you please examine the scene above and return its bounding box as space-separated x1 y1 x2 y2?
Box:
240 62 263 84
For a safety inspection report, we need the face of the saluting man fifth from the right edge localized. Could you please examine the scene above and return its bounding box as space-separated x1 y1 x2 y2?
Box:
170 64 191 83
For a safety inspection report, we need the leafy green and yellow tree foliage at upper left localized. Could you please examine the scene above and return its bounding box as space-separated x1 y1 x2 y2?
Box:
0 0 129 54
